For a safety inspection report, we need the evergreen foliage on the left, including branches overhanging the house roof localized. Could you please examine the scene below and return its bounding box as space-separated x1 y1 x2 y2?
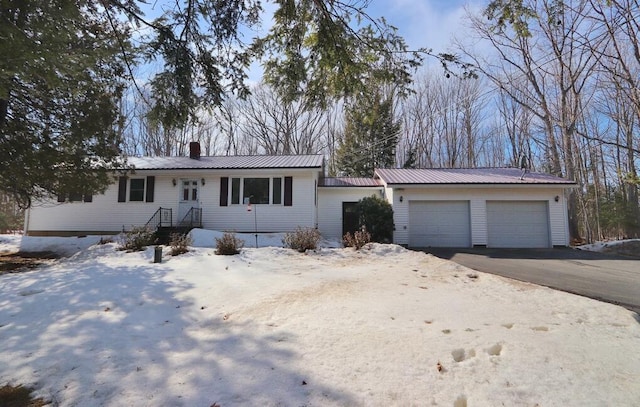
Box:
0 0 440 206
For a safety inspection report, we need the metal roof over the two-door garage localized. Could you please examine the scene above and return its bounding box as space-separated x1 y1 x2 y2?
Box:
375 168 575 186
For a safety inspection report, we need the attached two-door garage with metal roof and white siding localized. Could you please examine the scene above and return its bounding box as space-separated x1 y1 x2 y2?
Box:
375 168 575 248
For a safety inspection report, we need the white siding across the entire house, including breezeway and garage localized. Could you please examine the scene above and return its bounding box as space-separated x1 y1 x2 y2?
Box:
25 169 569 246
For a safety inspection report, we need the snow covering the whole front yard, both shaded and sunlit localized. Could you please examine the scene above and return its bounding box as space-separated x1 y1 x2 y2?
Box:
0 231 640 407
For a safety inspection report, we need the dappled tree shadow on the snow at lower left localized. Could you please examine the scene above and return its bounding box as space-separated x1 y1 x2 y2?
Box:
0 247 354 406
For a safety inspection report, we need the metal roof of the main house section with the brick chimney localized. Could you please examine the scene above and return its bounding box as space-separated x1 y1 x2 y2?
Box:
127 155 323 170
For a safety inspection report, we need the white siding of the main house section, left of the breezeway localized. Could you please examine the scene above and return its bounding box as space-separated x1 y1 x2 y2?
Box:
25 169 319 235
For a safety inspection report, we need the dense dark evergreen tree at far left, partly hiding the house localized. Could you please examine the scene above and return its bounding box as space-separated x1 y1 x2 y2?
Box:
0 0 126 207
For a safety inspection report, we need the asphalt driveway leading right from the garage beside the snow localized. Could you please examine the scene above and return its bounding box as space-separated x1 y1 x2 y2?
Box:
423 247 640 320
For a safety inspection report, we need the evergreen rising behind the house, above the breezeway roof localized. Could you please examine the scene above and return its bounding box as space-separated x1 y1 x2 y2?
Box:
336 94 401 177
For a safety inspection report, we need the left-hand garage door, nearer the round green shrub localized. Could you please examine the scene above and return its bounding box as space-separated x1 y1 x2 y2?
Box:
409 201 471 247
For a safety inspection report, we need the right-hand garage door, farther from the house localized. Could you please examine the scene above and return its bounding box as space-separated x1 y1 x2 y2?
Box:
487 201 550 248
